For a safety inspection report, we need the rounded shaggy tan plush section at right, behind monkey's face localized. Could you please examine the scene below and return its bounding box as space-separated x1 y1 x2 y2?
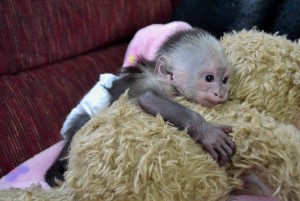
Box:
222 30 300 128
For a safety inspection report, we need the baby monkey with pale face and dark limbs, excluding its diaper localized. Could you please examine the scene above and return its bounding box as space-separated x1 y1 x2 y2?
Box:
46 28 235 186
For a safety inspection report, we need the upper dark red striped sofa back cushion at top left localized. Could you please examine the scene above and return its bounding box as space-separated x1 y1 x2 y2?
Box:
0 0 171 74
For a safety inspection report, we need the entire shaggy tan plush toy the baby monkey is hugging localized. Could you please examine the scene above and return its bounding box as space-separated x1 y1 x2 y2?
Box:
0 30 300 201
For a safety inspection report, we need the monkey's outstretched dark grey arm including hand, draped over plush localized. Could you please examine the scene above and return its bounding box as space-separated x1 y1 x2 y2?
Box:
138 90 235 166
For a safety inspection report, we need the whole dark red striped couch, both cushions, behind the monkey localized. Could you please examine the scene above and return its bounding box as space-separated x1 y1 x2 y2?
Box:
0 0 174 177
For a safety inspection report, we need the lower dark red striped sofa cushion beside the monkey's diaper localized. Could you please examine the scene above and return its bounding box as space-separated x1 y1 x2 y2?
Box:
0 45 127 175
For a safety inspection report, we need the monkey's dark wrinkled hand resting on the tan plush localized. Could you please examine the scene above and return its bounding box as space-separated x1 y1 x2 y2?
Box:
188 117 235 166
